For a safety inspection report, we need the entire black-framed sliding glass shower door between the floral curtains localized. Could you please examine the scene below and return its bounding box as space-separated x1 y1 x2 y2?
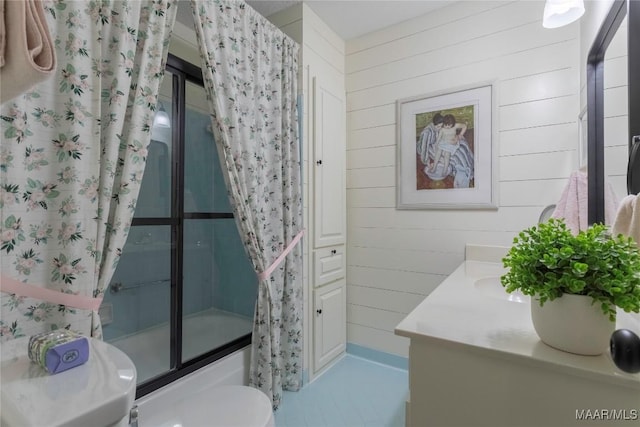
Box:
101 55 257 397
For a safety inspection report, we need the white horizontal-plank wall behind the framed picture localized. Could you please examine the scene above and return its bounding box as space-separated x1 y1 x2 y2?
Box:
346 1 583 356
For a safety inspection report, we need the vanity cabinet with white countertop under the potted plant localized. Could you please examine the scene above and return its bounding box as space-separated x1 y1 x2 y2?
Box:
396 261 640 427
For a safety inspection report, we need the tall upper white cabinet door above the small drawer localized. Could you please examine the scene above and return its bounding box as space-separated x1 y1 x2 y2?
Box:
311 77 346 248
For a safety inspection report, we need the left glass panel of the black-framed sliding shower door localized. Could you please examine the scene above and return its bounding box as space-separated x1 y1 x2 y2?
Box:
101 72 173 383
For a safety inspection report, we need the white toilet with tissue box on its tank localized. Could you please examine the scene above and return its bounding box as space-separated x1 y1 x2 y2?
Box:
0 337 275 427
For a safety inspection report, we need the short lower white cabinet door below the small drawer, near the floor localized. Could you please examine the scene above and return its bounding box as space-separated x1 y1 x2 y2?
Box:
314 280 347 372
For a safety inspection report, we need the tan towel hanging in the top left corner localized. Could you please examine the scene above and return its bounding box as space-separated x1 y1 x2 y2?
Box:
0 0 56 103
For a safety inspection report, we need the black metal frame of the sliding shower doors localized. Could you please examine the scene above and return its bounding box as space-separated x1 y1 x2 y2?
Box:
131 54 251 399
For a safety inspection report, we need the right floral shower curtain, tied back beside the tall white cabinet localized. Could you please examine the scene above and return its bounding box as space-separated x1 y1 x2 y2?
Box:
191 0 302 408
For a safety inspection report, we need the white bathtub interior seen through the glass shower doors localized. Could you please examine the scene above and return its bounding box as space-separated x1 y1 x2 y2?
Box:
109 309 253 388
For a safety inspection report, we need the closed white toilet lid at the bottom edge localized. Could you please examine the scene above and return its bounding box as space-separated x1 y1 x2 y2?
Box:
140 386 274 427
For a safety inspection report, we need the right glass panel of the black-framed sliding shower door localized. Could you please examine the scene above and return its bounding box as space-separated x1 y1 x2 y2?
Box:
182 82 257 361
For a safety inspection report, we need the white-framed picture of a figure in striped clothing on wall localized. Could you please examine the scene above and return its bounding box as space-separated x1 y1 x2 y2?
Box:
396 83 497 209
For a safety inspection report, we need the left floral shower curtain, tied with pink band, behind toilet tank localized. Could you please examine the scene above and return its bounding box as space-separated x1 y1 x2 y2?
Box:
0 0 177 340
